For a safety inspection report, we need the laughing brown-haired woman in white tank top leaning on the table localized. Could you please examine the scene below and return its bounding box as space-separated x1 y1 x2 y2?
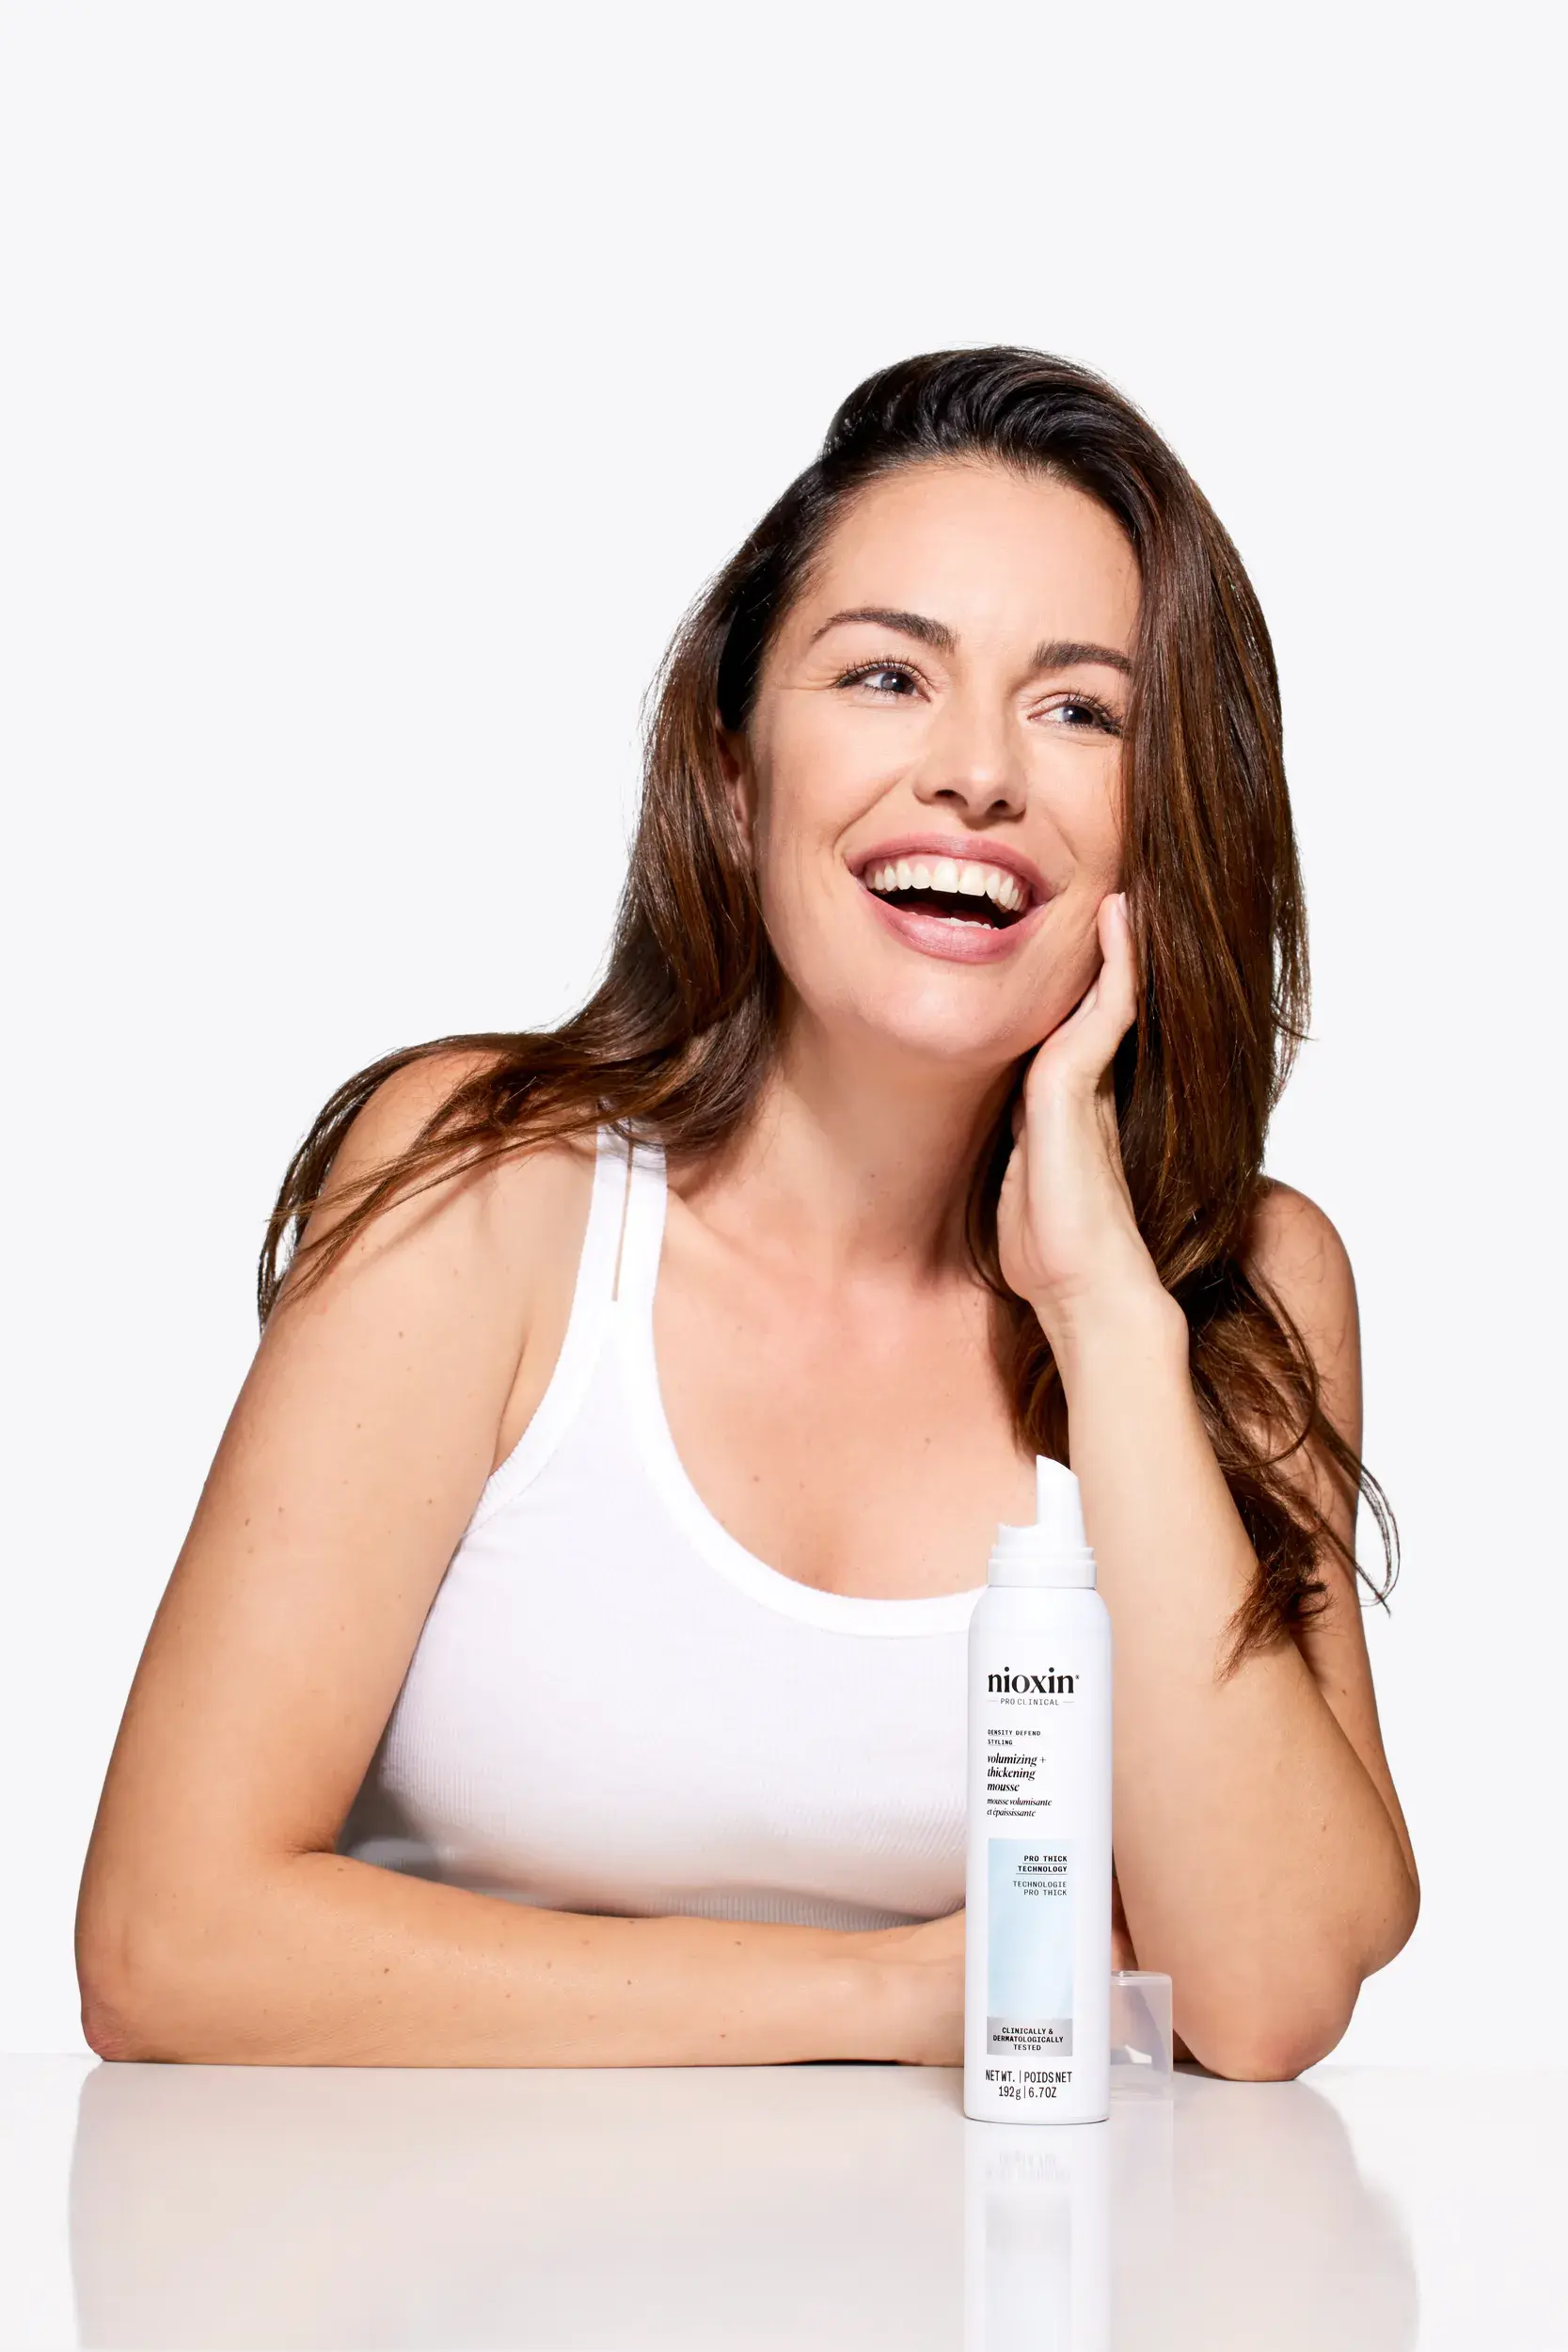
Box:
77 351 1418 2077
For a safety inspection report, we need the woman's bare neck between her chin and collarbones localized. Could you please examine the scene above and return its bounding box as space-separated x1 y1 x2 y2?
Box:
679 1014 1011 1284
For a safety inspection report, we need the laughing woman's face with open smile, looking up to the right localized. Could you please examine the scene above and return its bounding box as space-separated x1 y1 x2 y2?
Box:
731 461 1138 1071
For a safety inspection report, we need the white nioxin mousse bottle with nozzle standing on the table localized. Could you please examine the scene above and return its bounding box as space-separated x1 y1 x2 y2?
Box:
964 1454 1112 2124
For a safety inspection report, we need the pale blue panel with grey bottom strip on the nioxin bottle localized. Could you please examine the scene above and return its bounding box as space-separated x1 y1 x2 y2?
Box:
985 1837 1072 2058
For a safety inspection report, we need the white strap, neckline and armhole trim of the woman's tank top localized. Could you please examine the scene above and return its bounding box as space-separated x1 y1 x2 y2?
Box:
475 1127 983 1637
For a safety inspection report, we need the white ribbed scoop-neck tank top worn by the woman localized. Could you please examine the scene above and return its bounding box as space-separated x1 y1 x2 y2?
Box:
339 1129 978 1929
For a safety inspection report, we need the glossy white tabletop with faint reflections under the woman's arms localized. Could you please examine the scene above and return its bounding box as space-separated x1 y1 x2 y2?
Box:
0 2058 1568 2352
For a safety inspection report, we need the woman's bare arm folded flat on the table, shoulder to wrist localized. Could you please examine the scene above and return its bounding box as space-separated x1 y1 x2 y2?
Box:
77 1066 921 2065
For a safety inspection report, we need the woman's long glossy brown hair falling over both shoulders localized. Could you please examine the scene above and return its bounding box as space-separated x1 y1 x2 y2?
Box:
259 348 1397 1665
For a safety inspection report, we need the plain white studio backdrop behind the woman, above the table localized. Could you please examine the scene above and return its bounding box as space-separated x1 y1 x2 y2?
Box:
0 0 1568 2063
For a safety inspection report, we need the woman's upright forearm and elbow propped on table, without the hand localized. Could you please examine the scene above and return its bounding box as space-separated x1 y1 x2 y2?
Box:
1051 1282 1416 2074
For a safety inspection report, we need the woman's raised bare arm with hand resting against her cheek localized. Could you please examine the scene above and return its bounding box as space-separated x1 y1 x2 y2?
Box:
997 892 1418 2077
